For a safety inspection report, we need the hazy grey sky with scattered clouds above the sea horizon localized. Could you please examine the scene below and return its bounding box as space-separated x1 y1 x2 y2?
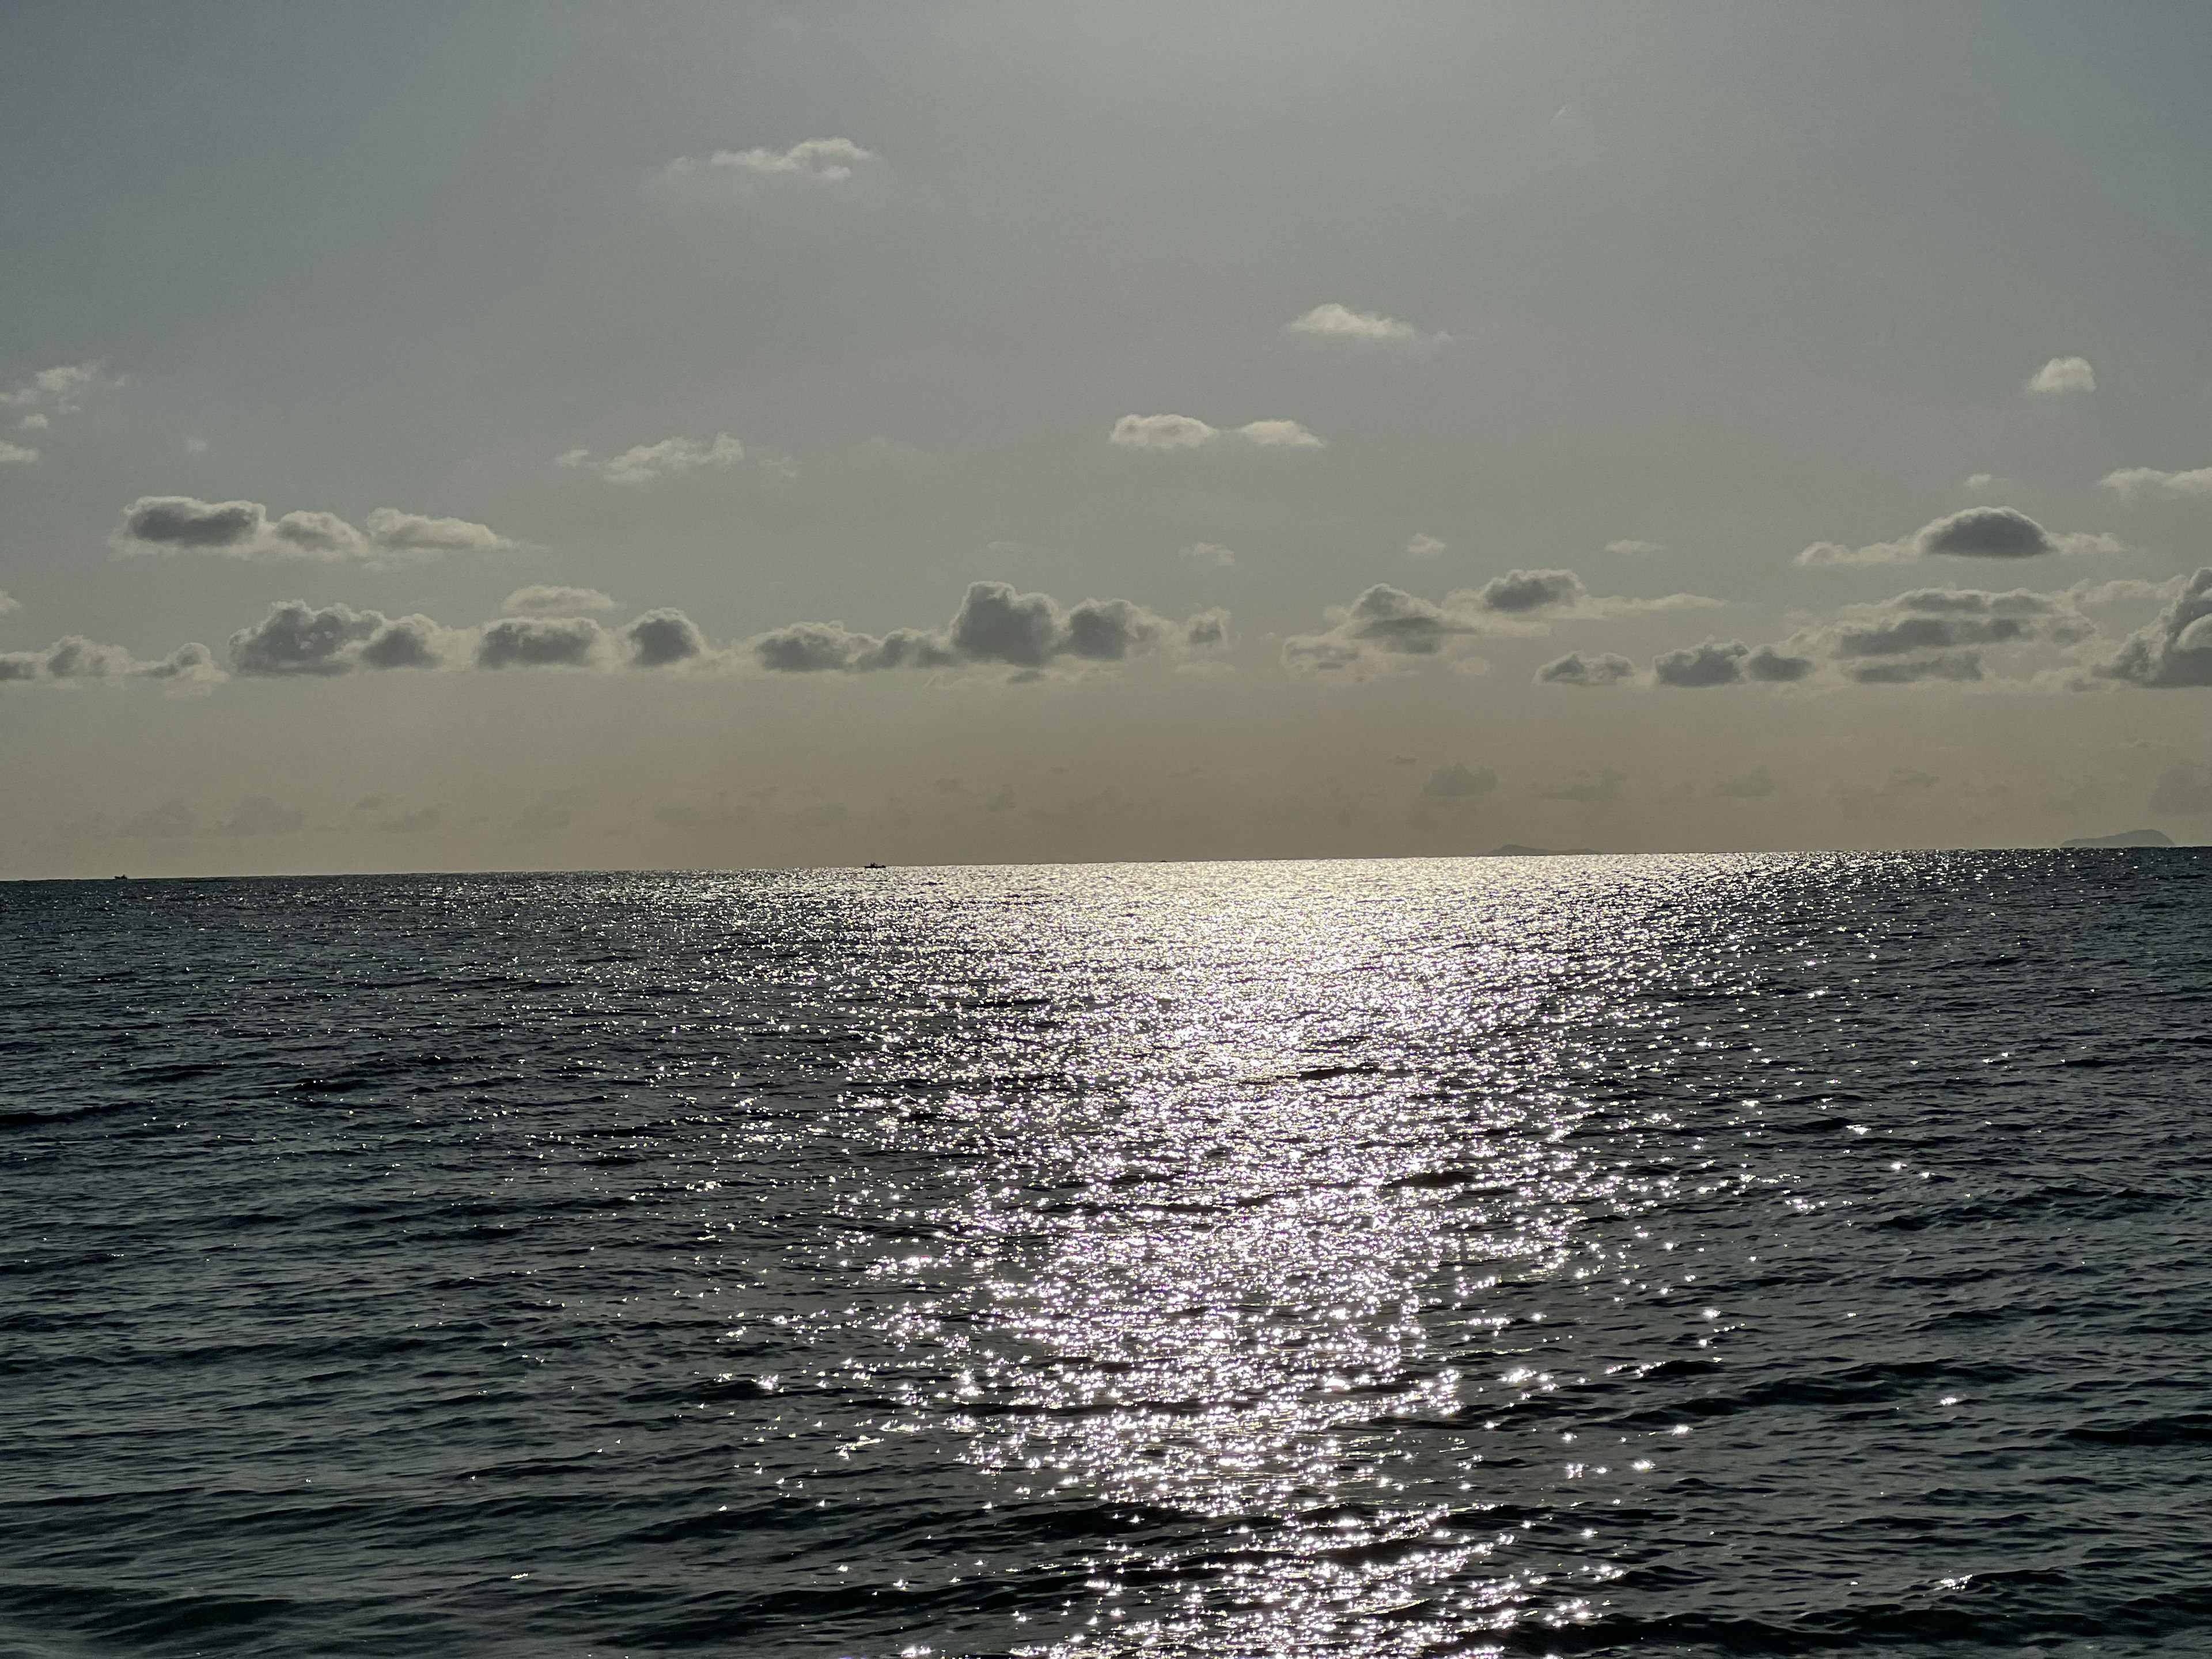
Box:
0 0 2212 878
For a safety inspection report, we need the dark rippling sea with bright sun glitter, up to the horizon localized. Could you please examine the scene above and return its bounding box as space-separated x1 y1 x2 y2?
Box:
0 850 2212 1659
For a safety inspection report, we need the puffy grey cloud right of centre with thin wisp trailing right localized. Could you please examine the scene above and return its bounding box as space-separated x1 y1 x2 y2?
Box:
1283 571 1721 672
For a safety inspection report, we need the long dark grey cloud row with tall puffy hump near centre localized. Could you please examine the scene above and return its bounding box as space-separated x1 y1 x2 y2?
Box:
748 582 1228 675
